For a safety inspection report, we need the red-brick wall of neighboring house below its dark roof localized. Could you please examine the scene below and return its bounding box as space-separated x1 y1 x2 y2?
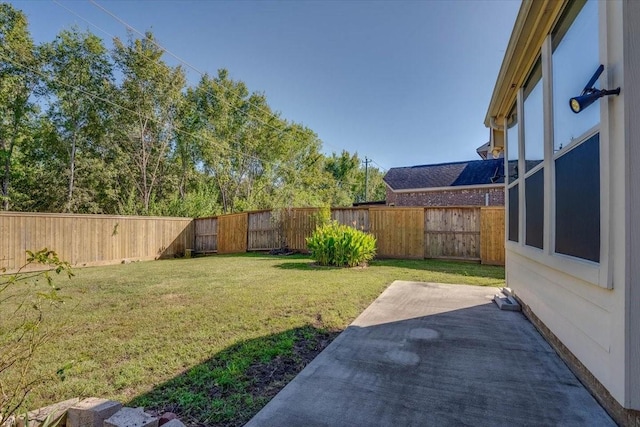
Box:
387 187 504 206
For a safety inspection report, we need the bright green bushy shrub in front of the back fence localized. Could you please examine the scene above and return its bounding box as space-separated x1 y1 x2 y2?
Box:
307 221 376 267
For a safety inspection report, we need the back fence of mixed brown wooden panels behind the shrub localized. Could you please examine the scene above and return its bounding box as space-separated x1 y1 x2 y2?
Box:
194 206 504 265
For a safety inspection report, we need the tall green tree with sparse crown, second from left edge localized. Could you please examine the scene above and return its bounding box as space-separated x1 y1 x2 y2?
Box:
42 28 113 212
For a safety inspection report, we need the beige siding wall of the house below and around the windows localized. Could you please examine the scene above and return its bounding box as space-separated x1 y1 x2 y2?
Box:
506 1 640 425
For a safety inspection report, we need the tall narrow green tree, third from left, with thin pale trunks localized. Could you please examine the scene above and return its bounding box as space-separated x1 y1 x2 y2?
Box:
114 32 186 213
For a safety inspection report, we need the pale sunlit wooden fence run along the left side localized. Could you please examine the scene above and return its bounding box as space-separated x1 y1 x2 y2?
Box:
0 212 194 272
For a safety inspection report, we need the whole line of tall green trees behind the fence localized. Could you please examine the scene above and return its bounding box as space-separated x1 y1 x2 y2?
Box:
0 3 385 217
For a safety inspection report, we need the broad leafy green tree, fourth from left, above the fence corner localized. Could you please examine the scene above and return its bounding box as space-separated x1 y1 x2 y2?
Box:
187 70 286 213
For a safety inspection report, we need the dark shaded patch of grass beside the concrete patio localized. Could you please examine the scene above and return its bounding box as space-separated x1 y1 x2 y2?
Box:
127 325 339 427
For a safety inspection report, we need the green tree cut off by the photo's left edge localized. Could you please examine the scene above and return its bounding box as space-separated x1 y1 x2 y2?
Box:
0 3 38 210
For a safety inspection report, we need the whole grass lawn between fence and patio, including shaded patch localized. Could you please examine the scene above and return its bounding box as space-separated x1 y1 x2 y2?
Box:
0 254 504 426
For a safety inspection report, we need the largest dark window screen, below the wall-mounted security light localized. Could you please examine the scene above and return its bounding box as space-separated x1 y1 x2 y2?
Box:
556 134 600 262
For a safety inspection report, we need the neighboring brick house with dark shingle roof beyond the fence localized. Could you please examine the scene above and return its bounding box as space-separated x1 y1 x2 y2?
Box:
384 159 504 206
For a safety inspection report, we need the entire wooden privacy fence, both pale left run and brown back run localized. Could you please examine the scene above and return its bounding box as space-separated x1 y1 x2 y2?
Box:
0 207 504 272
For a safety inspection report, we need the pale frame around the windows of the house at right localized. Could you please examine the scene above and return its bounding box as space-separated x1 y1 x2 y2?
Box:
504 2 613 289
